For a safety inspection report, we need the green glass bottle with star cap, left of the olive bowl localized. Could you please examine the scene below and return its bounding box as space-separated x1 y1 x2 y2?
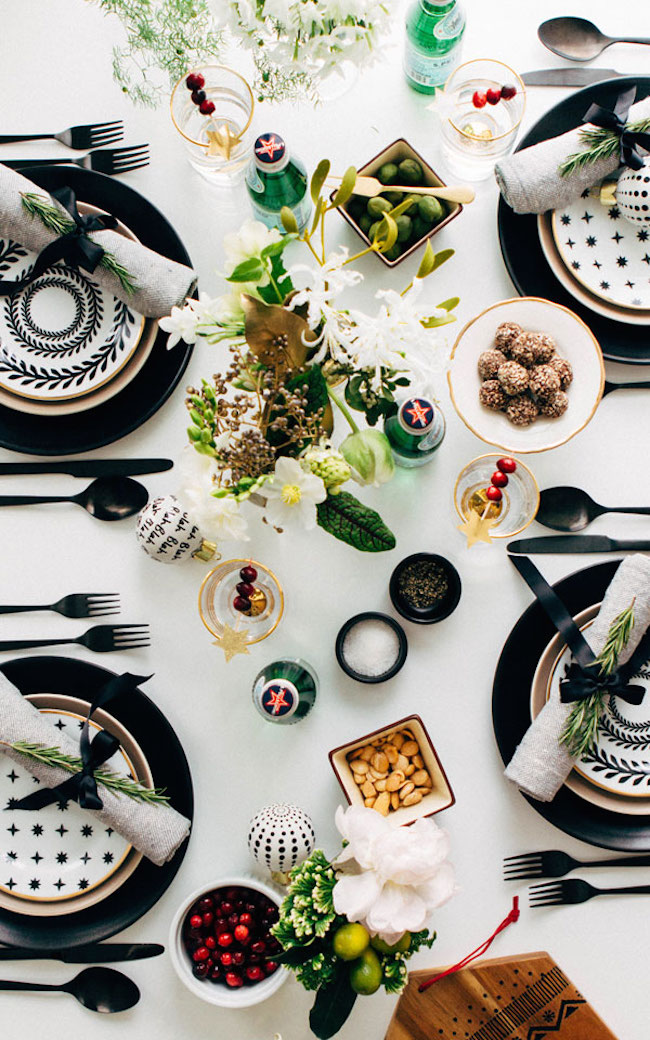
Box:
245 133 311 232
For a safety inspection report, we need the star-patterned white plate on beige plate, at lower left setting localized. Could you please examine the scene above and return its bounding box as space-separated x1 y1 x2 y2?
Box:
0 694 148 916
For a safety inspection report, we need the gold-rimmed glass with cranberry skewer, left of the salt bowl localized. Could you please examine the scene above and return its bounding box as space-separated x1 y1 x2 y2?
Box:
199 560 284 645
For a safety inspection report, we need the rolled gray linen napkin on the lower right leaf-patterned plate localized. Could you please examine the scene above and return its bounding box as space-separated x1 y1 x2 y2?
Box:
505 554 650 802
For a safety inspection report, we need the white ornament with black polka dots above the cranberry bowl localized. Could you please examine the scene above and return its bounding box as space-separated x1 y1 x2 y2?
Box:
249 803 316 884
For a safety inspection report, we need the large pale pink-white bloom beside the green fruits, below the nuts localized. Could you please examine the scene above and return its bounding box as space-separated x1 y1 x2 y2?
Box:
333 805 456 944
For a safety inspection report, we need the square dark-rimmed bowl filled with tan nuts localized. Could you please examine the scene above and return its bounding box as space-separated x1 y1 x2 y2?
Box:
330 714 456 825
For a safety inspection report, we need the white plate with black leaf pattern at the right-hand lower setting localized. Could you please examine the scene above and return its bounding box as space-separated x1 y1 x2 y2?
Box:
548 626 650 798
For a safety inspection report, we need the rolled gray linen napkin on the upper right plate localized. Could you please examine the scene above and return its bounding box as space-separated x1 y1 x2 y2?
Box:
494 97 650 213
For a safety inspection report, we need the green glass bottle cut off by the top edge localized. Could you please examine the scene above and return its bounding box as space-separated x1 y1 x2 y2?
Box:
404 0 465 94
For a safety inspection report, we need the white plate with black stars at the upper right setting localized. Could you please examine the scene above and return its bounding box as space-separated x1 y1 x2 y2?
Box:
552 192 650 309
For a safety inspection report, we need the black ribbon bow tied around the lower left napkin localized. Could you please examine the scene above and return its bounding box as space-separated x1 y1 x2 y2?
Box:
9 672 151 810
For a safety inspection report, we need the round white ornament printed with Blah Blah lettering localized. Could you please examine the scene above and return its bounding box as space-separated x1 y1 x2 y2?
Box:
135 495 216 564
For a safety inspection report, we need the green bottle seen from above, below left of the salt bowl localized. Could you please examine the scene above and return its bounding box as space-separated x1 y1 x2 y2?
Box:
253 657 318 726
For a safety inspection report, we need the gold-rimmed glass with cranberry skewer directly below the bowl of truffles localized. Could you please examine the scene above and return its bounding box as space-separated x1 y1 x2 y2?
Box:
453 453 540 538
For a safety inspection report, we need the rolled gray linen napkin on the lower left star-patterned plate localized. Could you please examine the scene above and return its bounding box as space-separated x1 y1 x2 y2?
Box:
0 673 189 866
